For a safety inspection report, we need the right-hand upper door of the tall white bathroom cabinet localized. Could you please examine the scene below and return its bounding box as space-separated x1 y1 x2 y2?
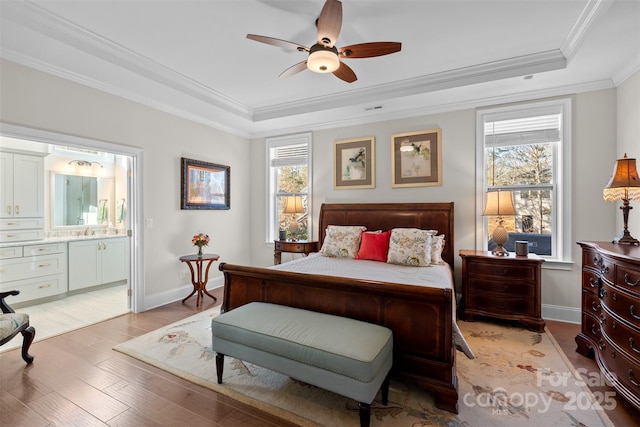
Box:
13 154 44 218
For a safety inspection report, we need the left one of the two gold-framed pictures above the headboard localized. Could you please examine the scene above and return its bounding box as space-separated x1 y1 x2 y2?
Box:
333 136 376 189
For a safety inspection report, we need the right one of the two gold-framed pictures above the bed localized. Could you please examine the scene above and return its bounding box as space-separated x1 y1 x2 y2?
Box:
391 129 442 187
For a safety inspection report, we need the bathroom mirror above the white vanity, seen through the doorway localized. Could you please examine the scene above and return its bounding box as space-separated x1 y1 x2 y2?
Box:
51 173 115 227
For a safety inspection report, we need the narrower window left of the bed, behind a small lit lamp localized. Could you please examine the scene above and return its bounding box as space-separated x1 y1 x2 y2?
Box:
266 133 312 242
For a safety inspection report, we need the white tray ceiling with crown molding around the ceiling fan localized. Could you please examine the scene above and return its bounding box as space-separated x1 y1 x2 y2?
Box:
0 0 640 137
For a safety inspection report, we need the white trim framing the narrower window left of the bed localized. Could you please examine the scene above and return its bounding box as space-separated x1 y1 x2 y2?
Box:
265 132 313 244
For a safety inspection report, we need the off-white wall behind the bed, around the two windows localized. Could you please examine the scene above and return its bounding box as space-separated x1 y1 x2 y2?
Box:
251 90 624 322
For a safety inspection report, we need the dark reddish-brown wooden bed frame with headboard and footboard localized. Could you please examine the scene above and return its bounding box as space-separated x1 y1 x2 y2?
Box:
219 202 458 413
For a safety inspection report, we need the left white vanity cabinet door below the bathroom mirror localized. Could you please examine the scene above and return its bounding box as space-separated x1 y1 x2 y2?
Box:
69 240 102 291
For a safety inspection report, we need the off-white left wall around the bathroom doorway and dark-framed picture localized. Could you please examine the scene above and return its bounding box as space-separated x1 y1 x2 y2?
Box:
0 60 250 308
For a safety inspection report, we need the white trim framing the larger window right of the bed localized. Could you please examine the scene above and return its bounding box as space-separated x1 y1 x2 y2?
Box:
476 98 573 270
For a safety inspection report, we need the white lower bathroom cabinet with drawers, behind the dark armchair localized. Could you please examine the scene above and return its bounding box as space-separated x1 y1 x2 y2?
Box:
0 243 67 304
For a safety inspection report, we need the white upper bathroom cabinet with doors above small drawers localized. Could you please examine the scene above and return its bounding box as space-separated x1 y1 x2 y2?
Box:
0 152 44 242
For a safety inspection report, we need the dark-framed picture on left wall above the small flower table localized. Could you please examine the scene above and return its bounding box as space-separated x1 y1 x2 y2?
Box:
181 157 231 209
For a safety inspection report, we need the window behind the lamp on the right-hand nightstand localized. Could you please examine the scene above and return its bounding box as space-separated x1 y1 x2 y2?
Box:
477 99 571 268
